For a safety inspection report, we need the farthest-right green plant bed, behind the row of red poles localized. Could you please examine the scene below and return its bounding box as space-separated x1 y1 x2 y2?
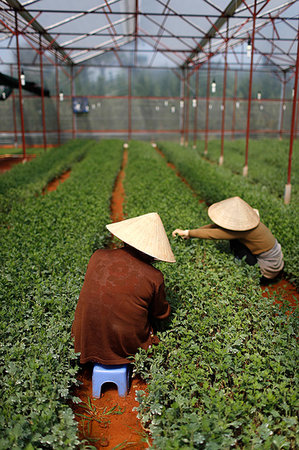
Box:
197 139 299 203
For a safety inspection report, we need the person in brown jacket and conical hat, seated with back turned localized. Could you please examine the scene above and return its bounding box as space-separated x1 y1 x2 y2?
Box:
72 213 175 365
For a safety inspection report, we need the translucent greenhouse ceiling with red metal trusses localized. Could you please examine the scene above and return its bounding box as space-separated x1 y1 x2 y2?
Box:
0 0 299 73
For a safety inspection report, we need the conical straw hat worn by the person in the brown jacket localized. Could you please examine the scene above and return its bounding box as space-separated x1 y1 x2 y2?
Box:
106 213 175 262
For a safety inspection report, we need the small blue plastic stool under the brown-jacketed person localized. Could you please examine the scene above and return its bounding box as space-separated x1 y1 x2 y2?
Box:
92 364 130 398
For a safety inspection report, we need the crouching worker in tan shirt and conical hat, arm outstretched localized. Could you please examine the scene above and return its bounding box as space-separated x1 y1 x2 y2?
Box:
172 197 284 281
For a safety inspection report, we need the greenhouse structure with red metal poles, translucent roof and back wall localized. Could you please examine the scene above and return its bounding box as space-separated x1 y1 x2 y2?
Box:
0 0 298 201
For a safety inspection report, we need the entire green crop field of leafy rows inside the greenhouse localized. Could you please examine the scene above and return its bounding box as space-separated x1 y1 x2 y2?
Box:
0 140 299 450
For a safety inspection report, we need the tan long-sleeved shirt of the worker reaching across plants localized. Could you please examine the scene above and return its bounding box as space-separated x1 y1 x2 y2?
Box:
189 222 275 255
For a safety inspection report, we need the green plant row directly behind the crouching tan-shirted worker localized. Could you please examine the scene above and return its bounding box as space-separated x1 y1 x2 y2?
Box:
158 142 299 286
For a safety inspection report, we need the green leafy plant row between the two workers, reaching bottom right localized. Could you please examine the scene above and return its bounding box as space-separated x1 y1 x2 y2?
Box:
124 142 298 450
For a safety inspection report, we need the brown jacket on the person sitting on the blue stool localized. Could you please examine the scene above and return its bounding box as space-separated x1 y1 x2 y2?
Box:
72 247 170 365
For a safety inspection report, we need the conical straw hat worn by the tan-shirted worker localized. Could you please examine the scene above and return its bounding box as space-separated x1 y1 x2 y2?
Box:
208 197 260 231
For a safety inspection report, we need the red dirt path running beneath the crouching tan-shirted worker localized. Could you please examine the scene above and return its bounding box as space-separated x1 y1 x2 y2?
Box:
152 144 299 314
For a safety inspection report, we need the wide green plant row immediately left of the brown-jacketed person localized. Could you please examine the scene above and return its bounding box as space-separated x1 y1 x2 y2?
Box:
0 140 122 450
